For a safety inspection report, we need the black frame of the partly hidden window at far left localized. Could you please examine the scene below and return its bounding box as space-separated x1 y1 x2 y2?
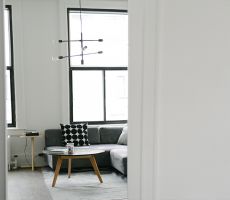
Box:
5 5 16 127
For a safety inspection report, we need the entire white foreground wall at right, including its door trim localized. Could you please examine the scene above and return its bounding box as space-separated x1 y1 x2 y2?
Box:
129 0 230 200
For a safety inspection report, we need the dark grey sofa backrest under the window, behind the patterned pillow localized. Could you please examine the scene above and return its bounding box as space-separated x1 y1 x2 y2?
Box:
45 125 123 147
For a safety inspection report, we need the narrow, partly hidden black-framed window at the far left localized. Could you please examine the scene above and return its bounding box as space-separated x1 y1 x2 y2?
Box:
4 5 16 127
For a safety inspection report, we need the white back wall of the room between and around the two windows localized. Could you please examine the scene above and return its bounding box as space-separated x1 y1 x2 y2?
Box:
6 0 127 166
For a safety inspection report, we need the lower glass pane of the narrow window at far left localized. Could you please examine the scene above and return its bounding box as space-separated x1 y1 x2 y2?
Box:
6 70 12 124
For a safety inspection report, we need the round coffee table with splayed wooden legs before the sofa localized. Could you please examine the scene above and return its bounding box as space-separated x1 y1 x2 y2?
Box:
44 148 105 187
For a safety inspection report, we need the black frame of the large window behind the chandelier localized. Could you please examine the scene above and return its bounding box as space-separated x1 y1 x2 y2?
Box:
67 8 128 124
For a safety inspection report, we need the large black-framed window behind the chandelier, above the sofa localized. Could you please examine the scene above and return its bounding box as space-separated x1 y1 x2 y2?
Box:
67 8 128 124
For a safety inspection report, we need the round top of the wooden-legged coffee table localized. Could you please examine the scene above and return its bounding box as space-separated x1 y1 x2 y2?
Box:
43 147 105 156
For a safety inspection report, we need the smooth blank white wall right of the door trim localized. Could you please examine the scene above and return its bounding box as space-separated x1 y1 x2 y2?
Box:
157 0 230 200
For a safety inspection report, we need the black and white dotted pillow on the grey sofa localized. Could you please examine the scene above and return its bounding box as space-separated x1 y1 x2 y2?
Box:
60 123 89 146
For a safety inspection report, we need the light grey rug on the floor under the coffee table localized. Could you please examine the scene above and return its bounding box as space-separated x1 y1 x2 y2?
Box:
42 170 128 200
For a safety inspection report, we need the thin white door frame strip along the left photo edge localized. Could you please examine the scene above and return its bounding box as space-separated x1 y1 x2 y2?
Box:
0 0 7 200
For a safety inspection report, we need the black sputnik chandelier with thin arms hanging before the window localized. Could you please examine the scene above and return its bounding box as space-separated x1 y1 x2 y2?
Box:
58 0 103 65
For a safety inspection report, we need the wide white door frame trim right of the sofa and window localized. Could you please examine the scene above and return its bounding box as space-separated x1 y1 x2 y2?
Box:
128 0 158 200
